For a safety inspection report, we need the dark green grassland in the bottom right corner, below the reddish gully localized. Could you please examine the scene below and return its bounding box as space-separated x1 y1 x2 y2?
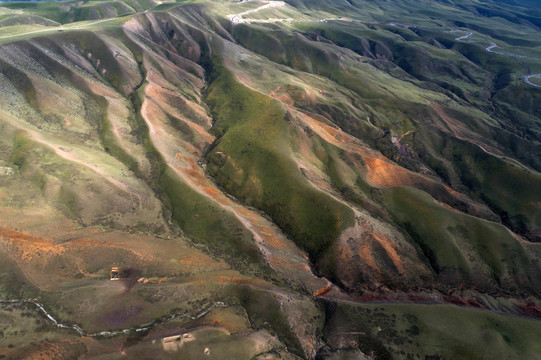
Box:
325 304 541 359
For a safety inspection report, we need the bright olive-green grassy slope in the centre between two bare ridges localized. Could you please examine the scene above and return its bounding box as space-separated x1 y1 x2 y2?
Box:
207 66 353 260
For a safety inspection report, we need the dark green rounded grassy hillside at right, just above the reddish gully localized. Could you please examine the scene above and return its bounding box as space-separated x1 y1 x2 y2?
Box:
384 188 538 290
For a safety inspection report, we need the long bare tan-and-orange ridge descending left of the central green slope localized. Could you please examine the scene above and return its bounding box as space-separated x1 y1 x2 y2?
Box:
127 15 336 293
